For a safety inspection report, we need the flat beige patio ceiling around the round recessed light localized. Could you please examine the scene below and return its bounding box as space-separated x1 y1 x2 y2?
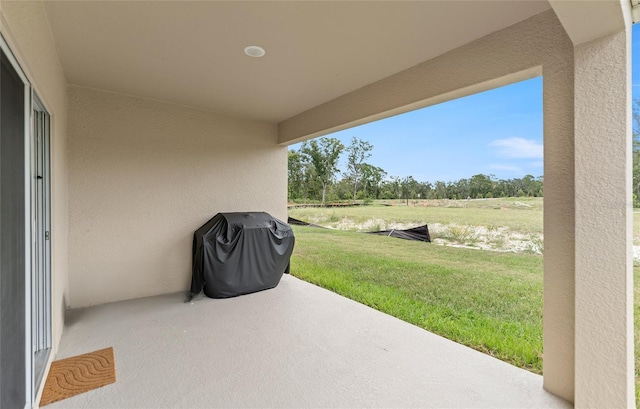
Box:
45 0 549 122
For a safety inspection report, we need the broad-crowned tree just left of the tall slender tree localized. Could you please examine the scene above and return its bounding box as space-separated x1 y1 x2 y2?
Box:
300 138 344 204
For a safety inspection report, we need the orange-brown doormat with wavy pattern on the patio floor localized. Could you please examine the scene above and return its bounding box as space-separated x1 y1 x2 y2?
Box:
40 347 116 406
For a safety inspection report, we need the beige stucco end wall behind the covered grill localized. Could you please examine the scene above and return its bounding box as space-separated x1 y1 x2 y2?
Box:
69 86 287 307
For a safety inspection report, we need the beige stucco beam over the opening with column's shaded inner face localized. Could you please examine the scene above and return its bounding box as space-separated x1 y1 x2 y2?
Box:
279 11 575 400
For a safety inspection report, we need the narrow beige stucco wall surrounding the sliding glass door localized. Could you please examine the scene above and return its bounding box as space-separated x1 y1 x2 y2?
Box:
0 1 68 350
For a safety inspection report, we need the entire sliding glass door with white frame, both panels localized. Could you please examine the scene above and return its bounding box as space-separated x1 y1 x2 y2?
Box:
0 36 51 408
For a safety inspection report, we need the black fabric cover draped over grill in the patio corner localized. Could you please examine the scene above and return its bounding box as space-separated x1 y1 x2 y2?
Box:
190 212 295 298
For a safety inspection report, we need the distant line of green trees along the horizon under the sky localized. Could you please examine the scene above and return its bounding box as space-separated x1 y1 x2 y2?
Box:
288 136 544 204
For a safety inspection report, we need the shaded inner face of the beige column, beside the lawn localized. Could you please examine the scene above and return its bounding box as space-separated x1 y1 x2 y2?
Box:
543 61 575 401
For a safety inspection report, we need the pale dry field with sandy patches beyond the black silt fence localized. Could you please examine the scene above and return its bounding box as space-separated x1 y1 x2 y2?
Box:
289 198 543 254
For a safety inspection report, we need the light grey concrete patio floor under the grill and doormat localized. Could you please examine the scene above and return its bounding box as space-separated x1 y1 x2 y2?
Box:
47 275 571 409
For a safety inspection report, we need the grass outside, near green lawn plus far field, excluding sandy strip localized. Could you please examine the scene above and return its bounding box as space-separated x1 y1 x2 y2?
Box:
289 198 640 398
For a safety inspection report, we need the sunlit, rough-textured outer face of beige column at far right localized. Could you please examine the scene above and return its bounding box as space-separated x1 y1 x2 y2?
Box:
572 26 635 408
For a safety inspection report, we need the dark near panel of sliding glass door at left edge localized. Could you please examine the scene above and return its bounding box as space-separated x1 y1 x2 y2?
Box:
0 39 31 408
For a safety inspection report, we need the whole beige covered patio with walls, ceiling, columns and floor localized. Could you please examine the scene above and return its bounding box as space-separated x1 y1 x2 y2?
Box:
0 0 640 409
